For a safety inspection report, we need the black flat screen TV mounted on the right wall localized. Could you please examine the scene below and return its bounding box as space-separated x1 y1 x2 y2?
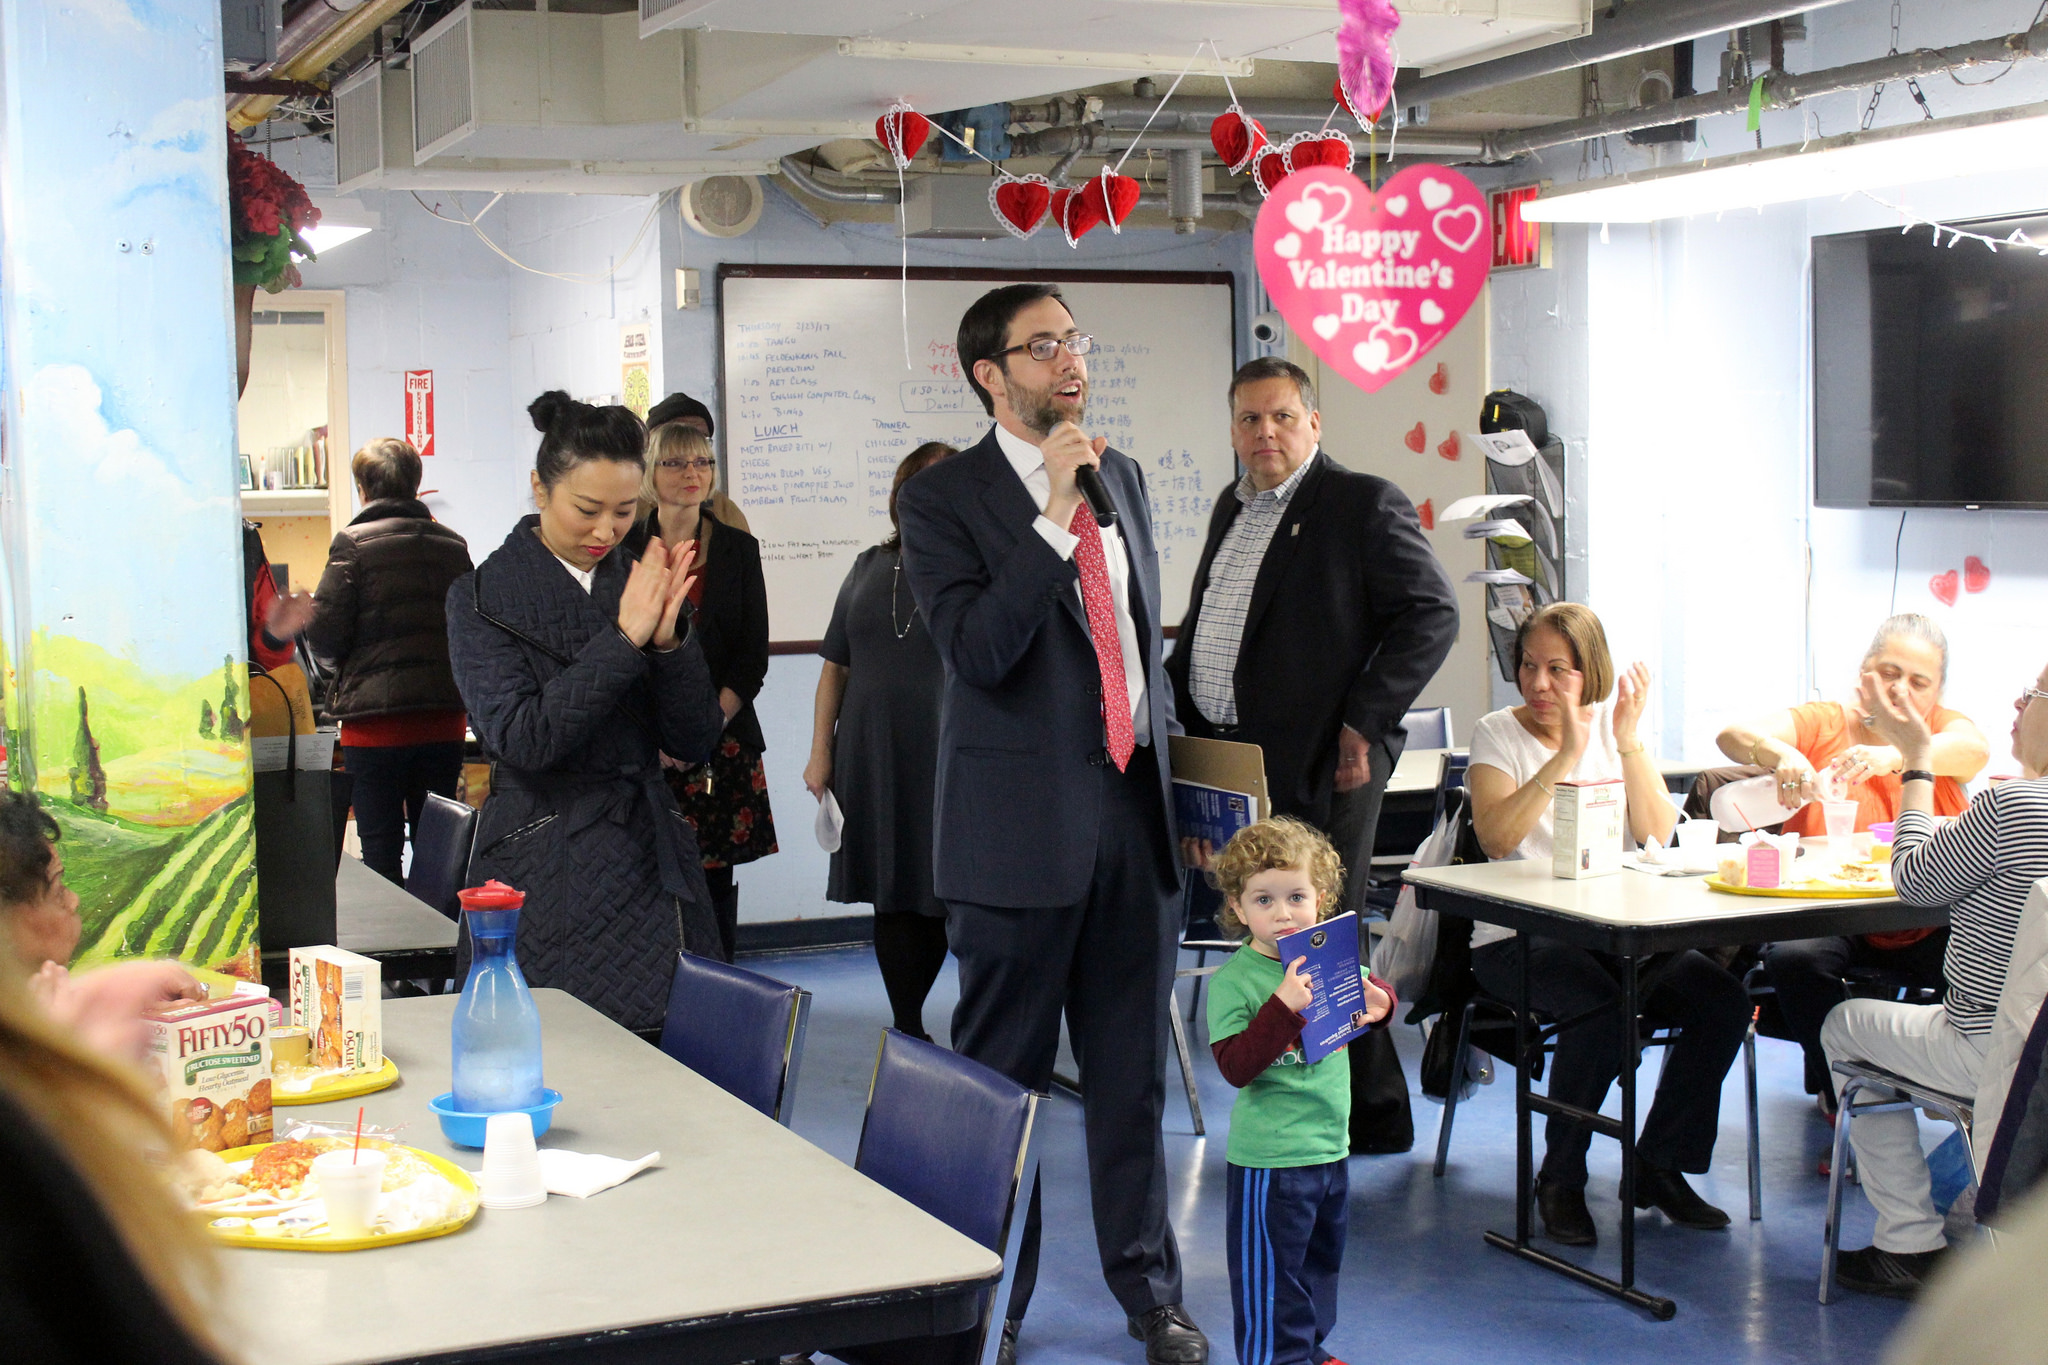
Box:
1812 217 2048 508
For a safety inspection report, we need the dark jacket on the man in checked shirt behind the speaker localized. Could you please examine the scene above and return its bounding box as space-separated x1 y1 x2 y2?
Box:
1165 452 1458 825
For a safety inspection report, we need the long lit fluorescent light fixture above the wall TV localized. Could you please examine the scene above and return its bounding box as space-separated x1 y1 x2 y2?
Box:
1522 102 2048 223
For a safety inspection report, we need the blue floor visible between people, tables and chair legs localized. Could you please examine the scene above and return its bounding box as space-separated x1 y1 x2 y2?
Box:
748 948 1933 1365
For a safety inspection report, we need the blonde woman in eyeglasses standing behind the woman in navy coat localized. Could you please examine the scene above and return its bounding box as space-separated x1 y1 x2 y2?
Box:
627 422 776 962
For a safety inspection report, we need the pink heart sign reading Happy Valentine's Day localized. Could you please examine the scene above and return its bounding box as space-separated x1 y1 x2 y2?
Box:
1253 166 1493 393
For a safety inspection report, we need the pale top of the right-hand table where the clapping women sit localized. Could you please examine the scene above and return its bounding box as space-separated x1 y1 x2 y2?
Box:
1403 857 1898 929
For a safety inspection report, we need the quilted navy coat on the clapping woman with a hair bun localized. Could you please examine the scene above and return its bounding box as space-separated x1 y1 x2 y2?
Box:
449 516 725 1029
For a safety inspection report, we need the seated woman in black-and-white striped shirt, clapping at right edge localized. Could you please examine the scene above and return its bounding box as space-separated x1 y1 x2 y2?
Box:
1821 654 2048 1297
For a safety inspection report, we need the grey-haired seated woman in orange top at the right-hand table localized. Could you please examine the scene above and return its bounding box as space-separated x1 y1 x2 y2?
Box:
1718 614 1991 1121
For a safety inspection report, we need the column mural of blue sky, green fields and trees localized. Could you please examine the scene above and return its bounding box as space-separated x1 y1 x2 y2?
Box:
0 0 256 976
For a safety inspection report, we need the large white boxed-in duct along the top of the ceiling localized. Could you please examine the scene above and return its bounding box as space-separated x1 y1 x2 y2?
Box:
385 0 1593 190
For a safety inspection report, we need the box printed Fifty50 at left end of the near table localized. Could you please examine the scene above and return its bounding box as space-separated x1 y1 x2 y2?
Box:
147 995 270 1152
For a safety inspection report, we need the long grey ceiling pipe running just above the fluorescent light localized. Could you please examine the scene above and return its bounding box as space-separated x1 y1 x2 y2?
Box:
1485 23 2048 162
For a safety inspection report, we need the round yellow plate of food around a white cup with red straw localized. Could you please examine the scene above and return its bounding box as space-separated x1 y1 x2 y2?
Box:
172 1136 477 1250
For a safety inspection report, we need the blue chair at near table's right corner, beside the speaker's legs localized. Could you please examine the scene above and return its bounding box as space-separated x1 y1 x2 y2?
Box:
825 1029 1038 1365
